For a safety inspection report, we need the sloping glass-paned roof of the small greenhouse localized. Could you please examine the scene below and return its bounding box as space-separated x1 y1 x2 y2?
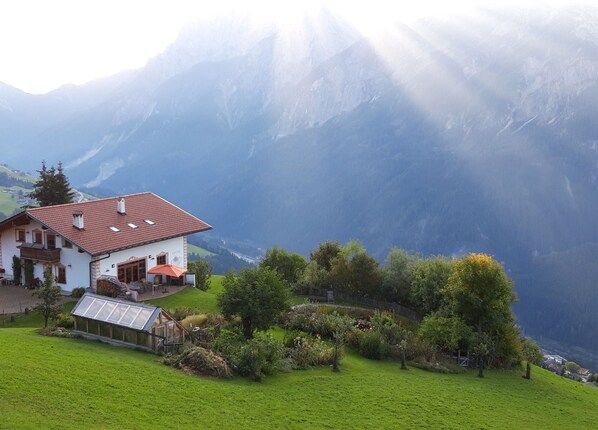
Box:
71 293 160 331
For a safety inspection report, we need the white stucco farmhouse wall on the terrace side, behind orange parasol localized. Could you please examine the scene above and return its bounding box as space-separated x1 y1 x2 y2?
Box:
100 237 187 281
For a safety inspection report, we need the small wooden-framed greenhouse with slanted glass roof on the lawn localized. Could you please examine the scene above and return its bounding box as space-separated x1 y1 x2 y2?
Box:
71 293 187 352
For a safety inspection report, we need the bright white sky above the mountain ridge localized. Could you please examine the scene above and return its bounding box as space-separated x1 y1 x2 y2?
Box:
0 0 576 94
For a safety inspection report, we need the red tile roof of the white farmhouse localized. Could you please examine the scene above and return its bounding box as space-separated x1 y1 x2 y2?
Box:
19 193 212 255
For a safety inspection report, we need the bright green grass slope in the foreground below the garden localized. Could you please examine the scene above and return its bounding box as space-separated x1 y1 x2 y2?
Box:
0 328 598 429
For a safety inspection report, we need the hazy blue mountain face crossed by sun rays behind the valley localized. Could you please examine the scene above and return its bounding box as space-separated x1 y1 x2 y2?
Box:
0 7 598 360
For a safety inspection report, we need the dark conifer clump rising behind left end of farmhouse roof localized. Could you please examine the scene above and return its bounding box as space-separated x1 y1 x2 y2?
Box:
29 161 75 206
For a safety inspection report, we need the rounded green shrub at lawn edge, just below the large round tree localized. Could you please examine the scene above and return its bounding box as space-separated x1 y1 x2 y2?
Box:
233 335 283 382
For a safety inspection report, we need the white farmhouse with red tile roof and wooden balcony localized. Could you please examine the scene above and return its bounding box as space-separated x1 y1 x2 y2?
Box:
0 193 212 291
